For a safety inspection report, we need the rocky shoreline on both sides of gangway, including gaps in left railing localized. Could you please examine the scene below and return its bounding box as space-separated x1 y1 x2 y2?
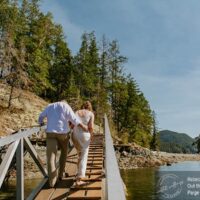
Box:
3 144 200 179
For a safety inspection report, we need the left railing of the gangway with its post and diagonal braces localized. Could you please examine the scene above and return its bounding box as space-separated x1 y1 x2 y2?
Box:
0 126 48 200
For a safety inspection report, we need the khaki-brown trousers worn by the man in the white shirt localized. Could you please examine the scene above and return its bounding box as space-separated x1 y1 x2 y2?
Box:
47 133 69 187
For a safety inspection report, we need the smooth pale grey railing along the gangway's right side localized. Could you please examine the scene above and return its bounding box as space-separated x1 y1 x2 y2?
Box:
104 114 126 200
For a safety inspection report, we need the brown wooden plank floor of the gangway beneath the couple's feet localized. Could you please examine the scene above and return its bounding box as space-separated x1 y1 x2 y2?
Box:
35 134 105 200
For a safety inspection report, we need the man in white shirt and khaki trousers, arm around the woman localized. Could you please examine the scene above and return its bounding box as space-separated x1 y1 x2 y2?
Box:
38 101 88 187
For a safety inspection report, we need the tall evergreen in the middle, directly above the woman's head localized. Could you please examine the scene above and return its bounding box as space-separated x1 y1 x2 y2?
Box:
74 32 99 99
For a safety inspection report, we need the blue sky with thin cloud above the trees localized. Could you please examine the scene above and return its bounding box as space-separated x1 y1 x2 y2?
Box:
41 0 200 137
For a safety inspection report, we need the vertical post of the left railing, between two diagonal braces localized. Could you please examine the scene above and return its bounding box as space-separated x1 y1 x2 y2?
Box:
16 138 24 200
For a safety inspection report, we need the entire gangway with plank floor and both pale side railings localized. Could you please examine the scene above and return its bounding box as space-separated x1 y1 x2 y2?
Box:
0 115 126 200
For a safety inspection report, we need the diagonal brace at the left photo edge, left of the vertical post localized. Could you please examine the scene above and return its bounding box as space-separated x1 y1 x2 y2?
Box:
0 140 19 188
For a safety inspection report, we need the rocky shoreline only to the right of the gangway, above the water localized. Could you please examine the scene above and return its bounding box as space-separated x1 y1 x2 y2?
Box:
115 145 200 169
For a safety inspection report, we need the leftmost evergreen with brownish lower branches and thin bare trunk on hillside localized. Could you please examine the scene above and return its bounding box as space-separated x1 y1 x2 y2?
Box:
0 1 28 107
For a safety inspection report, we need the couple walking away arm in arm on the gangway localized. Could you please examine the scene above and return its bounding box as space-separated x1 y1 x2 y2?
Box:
38 101 94 187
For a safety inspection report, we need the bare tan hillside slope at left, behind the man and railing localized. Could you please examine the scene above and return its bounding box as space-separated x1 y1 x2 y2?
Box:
0 83 47 136
